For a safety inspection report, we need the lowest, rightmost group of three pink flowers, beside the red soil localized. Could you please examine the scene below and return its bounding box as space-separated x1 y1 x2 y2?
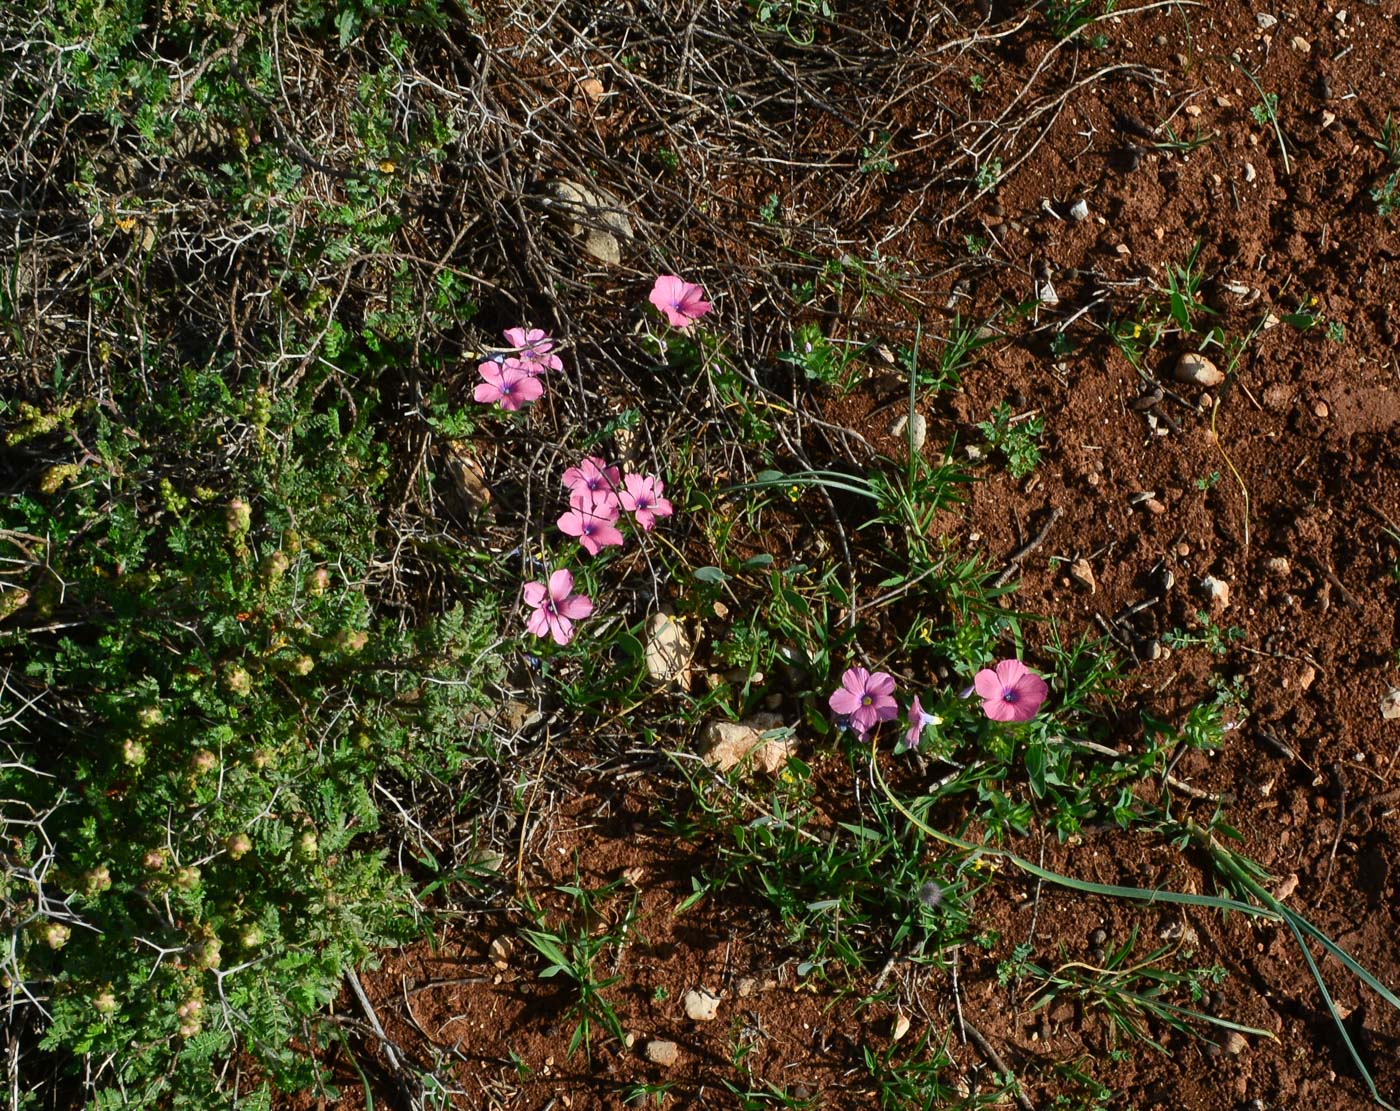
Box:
829 659 1050 749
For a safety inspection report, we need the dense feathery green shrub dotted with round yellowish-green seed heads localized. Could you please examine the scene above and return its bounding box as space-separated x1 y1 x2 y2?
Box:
0 358 498 1108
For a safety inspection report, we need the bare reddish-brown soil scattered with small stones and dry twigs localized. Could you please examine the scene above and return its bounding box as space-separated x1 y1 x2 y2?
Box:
287 0 1400 1111
